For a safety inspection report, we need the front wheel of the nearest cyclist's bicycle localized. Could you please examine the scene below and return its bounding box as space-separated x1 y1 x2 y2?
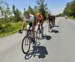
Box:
22 36 31 54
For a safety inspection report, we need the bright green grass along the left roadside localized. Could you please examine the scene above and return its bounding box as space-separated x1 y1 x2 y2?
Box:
0 22 22 37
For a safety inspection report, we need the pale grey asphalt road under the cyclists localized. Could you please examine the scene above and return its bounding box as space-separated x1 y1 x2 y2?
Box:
0 17 75 62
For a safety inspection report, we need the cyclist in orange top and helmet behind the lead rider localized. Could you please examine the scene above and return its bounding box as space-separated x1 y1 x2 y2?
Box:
36 13 44 36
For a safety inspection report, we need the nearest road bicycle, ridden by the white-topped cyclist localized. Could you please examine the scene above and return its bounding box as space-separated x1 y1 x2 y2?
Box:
21 30 39 54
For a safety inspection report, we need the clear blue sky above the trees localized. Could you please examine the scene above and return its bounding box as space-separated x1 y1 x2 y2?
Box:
6 0 71 15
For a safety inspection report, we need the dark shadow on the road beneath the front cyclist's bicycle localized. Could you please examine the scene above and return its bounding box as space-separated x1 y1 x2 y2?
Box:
25 46 48 60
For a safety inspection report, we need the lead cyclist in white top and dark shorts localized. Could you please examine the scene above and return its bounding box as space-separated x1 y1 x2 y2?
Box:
22 12 35 43
